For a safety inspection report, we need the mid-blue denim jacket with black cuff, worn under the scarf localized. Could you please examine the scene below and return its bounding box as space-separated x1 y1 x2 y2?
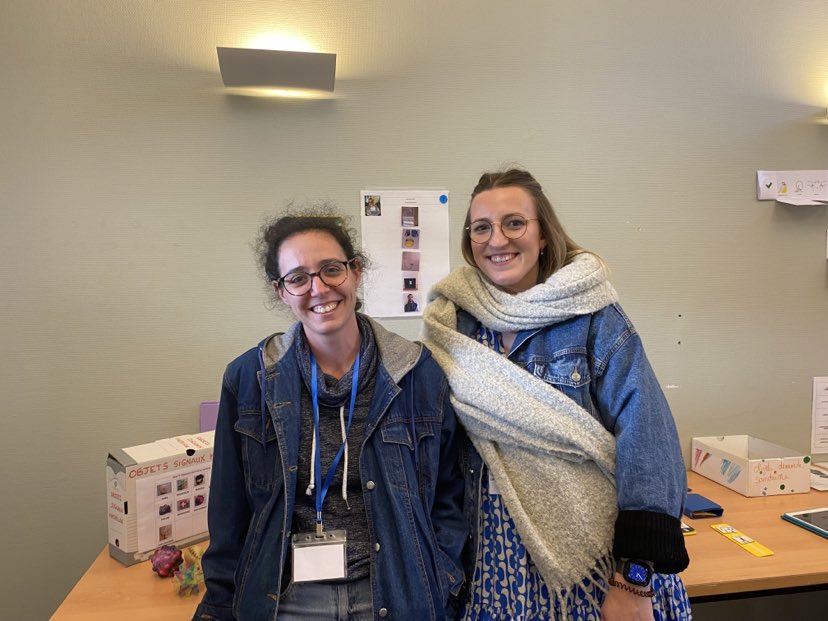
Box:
457 304 689 573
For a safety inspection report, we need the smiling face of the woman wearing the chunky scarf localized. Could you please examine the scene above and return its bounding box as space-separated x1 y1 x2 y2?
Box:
469 186 546 293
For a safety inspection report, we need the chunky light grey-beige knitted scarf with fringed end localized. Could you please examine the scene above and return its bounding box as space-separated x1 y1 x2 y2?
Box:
423 253 618 614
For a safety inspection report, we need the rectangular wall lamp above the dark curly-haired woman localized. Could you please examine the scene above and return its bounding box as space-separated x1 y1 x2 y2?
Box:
216 47 336 91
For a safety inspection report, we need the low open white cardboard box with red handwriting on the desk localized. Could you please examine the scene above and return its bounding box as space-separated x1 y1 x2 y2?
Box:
691 436 811 496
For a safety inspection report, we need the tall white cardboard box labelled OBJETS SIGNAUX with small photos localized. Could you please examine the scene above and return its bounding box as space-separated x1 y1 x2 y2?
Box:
106 431 214 565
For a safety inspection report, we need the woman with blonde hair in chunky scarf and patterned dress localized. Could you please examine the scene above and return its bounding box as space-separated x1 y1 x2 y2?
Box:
424 169 690 621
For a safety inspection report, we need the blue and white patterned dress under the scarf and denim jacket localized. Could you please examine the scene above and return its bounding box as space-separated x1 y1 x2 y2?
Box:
460 327 692 621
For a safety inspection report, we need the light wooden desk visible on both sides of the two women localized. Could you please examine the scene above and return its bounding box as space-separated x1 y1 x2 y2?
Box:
52 472 828 621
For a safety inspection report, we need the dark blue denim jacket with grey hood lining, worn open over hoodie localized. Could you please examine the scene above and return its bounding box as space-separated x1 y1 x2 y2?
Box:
193 321 467 621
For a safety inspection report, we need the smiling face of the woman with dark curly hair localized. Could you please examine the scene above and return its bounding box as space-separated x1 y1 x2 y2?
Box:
274 230 362 344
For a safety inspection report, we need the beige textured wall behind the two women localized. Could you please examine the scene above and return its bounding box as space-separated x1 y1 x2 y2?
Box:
0 0 828 620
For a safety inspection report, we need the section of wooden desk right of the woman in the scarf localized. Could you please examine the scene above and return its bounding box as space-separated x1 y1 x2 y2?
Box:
681 472 828 598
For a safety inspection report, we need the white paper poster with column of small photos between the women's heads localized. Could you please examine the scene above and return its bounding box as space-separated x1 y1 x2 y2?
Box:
360 189 450 317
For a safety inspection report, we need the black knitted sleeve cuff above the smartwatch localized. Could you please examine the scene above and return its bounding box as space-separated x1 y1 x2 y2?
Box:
612 511 690 574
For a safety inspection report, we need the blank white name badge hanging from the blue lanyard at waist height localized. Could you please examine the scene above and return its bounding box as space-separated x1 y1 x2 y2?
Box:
291 530 348 582
